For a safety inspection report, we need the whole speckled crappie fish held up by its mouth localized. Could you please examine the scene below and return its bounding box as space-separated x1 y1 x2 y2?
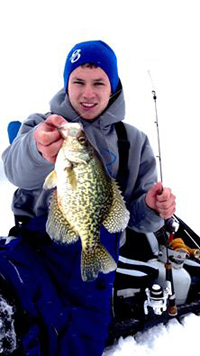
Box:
44 123 129 281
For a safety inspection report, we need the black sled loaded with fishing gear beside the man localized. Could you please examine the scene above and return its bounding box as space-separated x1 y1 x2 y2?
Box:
107 216 200 346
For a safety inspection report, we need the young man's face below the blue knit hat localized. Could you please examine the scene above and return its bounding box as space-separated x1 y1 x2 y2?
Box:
68 65 111 120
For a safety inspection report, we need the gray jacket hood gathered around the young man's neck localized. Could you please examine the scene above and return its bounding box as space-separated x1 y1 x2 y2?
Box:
50 89 125 128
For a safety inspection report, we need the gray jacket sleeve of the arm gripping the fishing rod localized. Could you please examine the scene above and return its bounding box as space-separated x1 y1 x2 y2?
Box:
128 133 164 233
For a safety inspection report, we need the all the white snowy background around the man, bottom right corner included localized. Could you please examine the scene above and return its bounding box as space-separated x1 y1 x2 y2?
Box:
0 0 200 356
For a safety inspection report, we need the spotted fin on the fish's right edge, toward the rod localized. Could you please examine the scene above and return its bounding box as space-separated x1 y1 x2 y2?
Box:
103 179 130 233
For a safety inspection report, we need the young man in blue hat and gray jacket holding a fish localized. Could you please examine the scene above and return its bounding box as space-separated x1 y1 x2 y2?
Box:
0 41 175 356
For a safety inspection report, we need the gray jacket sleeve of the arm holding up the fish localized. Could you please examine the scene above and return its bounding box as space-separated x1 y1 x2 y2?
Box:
2 114 54 190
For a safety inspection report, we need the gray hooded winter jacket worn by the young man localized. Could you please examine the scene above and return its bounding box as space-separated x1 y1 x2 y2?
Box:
2 90 163 232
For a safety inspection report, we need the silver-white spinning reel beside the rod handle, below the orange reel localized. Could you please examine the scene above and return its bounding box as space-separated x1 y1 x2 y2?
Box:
144 284 171 315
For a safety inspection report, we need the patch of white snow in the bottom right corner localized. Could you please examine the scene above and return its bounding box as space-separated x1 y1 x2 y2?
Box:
103 314 200 356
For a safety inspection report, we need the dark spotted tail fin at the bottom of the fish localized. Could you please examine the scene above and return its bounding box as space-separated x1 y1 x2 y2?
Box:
81 243 117 282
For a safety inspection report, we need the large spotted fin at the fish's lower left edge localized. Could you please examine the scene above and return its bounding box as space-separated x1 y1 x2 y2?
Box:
46 191 79 244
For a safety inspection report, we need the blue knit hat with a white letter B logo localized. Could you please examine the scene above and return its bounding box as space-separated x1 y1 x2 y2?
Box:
64 41 119 94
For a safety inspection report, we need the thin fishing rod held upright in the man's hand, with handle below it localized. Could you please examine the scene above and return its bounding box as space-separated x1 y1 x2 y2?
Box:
148 71 179 316
